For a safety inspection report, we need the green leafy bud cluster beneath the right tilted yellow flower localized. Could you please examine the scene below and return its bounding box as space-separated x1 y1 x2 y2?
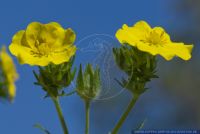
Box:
113 46 158 95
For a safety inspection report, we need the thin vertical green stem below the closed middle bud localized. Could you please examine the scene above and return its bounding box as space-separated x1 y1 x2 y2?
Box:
85 101 90 134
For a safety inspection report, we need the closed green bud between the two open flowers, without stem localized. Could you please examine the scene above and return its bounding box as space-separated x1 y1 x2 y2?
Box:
76 64 101 101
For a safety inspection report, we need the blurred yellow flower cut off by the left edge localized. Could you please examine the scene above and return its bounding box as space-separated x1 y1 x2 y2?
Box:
0 47 18 99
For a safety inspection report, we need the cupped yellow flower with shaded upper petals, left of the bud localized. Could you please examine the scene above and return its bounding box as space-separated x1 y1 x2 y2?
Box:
9 22 76 66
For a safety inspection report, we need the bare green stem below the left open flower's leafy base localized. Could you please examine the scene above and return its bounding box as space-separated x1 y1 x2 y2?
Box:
52 97 68 134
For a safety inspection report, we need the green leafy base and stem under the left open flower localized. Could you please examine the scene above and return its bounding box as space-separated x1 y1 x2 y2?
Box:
33 58 76 134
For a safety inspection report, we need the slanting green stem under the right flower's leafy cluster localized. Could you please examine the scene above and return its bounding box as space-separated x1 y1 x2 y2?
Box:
112 96 139 134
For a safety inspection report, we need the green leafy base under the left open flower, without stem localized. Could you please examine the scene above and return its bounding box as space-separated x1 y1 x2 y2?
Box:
33 58 76 97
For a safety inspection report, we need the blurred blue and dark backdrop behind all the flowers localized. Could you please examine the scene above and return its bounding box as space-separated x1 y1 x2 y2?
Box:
0 0 200 134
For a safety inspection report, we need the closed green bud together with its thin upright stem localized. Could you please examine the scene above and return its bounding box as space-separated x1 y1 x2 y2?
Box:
76 64 101 134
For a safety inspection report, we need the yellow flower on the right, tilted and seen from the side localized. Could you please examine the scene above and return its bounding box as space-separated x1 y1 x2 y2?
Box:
116 21 193 60
